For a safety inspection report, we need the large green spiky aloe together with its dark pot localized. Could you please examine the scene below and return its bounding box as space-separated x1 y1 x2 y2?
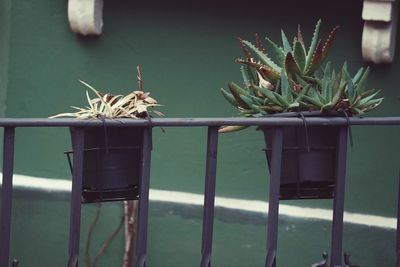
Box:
220 20 383 199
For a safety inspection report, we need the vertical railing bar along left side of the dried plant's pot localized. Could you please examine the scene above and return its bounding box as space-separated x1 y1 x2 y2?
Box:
68 128 85 267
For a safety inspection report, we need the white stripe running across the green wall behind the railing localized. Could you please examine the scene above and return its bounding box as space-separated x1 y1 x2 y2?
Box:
0 174 397 229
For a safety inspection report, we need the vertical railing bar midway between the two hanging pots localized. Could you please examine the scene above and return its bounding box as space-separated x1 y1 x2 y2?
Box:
200 126 218 267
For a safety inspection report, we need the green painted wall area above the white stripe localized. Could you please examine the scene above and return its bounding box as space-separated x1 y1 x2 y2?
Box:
6 1 400 216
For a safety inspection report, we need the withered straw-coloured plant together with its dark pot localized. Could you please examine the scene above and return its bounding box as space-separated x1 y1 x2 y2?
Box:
51 67 163 203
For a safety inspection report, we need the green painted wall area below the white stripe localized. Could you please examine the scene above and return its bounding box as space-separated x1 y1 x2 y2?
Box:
7 193 395 267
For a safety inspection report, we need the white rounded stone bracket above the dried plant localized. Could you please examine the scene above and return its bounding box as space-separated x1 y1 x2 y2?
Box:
68 0 103 35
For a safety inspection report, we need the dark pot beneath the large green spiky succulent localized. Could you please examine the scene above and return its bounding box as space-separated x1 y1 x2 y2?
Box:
261 112 346 199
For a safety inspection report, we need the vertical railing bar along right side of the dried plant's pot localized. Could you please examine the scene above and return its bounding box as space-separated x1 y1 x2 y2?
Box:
135 127 152 267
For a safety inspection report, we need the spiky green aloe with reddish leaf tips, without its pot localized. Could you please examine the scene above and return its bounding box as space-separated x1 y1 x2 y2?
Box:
221 20 383 132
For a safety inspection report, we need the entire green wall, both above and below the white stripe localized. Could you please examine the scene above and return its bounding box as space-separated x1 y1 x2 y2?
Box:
0 0 400 267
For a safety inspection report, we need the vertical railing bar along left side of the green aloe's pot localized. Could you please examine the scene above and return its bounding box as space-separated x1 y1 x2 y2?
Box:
265 127 283 267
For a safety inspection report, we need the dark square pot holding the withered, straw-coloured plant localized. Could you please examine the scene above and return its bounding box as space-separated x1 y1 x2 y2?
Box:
69 127 144 203
